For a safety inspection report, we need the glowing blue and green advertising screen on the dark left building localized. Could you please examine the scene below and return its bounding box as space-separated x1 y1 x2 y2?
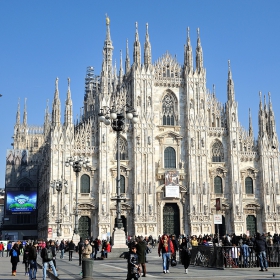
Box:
6 191 37 214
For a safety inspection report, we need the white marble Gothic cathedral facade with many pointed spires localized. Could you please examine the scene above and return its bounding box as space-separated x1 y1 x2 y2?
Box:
3 18 280 241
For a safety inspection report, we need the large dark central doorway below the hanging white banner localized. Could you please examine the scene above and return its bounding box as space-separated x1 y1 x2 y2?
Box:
163 203 180 237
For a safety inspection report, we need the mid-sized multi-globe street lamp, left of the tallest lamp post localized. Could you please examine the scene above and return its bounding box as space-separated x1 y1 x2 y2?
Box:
65 156 89 234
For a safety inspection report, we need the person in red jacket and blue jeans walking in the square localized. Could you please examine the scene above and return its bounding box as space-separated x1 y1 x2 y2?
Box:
158 234 174 273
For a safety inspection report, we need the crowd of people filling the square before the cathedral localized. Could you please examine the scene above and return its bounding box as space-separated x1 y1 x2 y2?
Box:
0 232 280 280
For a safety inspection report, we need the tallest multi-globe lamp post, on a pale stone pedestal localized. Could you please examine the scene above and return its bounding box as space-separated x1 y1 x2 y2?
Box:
98 105 138 238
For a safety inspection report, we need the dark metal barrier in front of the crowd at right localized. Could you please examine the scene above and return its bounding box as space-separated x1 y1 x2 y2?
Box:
190 244 280 269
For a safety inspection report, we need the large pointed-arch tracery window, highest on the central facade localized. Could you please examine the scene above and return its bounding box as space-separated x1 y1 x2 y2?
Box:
162 92 177 125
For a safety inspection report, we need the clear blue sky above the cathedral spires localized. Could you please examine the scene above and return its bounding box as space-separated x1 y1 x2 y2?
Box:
0 0 280 188
